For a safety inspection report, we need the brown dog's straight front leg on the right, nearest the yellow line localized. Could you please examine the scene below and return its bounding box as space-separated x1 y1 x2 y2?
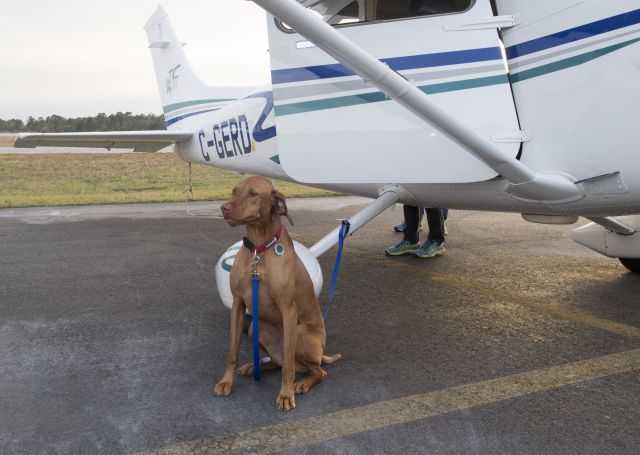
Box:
276 301 298 411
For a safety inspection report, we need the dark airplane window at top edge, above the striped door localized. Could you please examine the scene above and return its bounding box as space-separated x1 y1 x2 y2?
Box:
277 0 474 32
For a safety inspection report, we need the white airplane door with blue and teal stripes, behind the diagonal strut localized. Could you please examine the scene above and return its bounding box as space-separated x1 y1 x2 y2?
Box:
268 0 520 183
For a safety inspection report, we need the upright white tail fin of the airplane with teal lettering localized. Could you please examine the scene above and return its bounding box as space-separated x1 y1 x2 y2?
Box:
144 6 248 129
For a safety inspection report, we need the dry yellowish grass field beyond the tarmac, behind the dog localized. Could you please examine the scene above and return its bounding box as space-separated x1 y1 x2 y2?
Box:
0 153 337 208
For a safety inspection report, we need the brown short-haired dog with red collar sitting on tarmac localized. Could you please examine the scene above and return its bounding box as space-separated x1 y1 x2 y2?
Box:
214 177 340 411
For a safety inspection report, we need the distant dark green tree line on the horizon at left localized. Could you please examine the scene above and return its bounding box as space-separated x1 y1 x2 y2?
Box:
0 112 165 133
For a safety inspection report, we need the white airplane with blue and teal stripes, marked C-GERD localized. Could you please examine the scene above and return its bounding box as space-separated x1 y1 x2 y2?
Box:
15 0 640 282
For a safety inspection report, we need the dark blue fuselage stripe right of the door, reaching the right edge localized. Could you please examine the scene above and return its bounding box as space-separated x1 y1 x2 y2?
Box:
506 10 640 60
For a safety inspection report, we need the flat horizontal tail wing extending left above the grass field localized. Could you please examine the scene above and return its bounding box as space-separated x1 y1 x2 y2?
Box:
13 130 193 152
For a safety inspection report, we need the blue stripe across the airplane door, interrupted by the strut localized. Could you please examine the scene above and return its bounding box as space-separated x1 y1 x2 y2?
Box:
271 47 502 84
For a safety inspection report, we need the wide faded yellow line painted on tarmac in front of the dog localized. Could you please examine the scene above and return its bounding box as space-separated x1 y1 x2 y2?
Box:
138 349 640 455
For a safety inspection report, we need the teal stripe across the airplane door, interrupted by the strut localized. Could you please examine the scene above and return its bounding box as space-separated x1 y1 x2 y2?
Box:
275 75 509 117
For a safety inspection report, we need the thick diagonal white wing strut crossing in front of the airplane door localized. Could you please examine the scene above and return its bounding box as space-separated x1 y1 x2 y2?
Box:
253 0 584 203
